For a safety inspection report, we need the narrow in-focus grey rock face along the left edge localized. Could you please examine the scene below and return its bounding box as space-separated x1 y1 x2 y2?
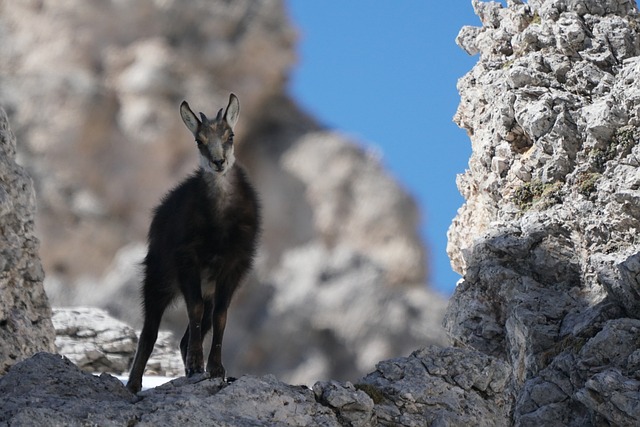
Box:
0 107 55 375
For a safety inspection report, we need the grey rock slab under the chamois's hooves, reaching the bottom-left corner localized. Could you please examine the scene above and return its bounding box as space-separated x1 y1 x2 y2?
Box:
0 353 342 426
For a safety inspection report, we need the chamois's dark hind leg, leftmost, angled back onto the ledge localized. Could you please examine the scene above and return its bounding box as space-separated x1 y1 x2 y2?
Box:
127 302 168 393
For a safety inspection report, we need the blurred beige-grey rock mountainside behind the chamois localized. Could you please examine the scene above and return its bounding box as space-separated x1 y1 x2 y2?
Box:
0 0 445 383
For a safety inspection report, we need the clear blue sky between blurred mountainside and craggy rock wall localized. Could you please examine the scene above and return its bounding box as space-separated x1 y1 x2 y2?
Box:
287 0 480 294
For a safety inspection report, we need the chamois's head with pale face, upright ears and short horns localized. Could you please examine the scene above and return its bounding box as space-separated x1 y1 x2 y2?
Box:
180 94 240 175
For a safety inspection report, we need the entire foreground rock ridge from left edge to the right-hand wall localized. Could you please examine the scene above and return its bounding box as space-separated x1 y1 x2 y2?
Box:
0 347 509 427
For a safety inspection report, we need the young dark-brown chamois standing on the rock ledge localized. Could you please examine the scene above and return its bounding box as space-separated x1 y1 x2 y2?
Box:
127 94 260 393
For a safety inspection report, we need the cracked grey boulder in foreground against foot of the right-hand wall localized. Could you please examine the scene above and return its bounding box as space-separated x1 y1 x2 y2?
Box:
355 346 511 426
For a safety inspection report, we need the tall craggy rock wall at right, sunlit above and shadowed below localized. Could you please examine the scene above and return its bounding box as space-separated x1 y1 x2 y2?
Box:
445 0 640 426
